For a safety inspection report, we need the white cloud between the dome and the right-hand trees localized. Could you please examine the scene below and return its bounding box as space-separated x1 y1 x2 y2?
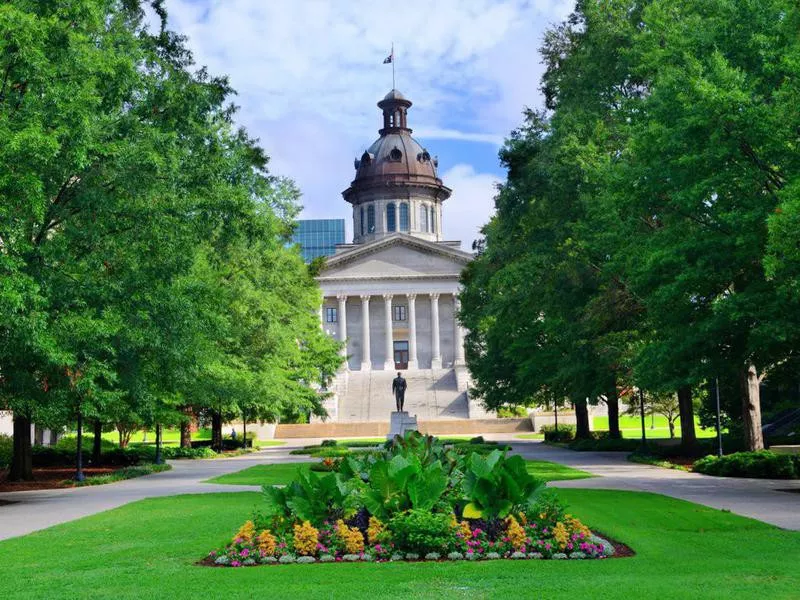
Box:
442 164 500 251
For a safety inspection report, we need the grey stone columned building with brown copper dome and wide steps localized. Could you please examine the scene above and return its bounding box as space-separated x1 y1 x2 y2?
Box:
317 90 485 422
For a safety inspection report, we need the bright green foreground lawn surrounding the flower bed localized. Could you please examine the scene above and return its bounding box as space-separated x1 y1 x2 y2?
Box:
0 489 800 600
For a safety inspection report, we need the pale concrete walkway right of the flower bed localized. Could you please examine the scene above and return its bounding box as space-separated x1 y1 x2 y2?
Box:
507 440 800 530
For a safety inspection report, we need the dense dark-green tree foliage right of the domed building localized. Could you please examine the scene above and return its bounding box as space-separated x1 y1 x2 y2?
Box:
462 0 800 449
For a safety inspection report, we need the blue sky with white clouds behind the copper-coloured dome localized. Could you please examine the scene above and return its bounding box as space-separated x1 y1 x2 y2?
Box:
158 0 573 249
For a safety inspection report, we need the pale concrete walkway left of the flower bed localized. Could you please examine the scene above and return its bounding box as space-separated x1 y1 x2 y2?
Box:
0 444 308 540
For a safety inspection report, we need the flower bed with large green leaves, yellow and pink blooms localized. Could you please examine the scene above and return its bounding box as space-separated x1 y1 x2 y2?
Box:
203 433 615 567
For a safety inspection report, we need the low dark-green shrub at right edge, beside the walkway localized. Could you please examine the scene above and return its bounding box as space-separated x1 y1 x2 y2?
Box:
692 450 800 479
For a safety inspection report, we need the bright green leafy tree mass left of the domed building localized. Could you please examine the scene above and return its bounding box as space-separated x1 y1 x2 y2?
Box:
0 0 340 476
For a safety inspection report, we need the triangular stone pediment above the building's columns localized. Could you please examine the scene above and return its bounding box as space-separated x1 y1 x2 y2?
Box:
319 234 472 281
